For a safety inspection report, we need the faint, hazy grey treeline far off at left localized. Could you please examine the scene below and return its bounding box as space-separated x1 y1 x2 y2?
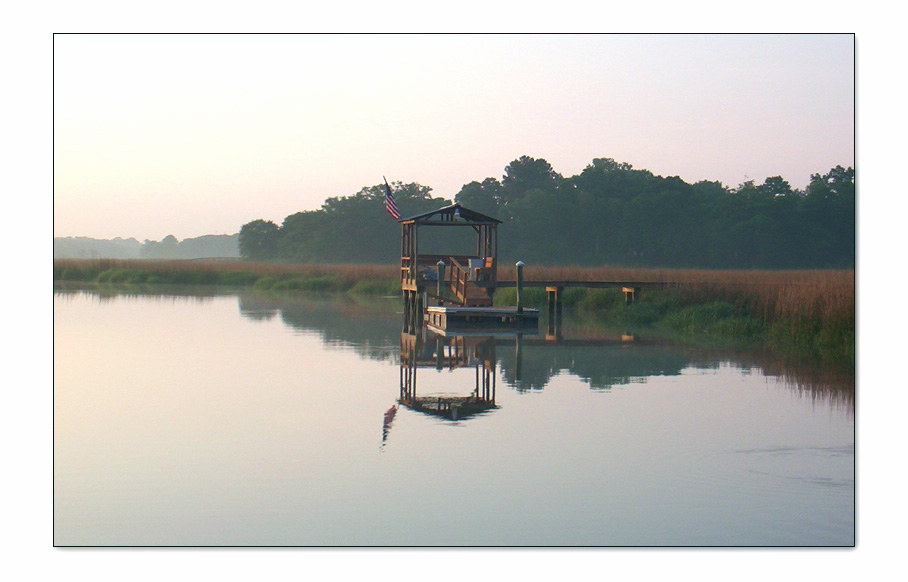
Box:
54 234 240 259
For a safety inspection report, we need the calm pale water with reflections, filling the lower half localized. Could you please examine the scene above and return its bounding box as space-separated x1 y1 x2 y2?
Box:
54 291 855 546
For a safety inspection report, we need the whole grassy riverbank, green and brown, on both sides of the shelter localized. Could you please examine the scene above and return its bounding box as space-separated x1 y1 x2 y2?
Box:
54 259 856 370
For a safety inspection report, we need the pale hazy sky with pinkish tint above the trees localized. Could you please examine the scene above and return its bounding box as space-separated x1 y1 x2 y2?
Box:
54 35 855 240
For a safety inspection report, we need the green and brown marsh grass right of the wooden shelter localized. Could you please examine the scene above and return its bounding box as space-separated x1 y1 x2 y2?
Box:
495 266 856 369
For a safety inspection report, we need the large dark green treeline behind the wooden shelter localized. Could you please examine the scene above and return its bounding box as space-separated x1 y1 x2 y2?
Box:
239 156 855 269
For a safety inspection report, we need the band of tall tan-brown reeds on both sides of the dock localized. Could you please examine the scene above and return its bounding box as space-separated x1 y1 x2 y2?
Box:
54 259 855 323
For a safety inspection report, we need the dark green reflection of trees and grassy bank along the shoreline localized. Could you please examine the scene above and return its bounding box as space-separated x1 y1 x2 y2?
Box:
54 287 855 414
